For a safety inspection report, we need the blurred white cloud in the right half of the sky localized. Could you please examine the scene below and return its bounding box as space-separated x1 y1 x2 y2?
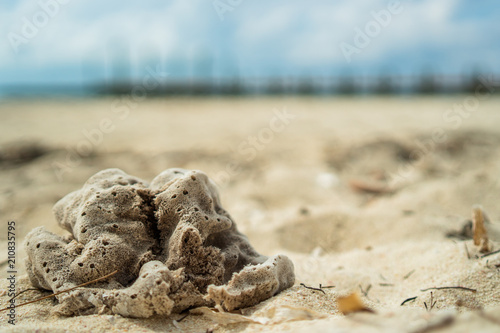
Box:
229 0 474 68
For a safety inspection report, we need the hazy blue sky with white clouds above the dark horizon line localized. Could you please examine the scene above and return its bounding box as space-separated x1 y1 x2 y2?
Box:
0 0 500 85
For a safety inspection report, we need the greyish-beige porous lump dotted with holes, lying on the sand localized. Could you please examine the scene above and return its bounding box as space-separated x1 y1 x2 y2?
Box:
25 169 295 318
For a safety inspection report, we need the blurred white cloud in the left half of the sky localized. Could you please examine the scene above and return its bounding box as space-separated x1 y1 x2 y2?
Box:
0 0 211 66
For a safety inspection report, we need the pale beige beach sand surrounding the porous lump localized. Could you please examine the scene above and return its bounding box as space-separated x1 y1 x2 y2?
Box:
0 96 500 332
